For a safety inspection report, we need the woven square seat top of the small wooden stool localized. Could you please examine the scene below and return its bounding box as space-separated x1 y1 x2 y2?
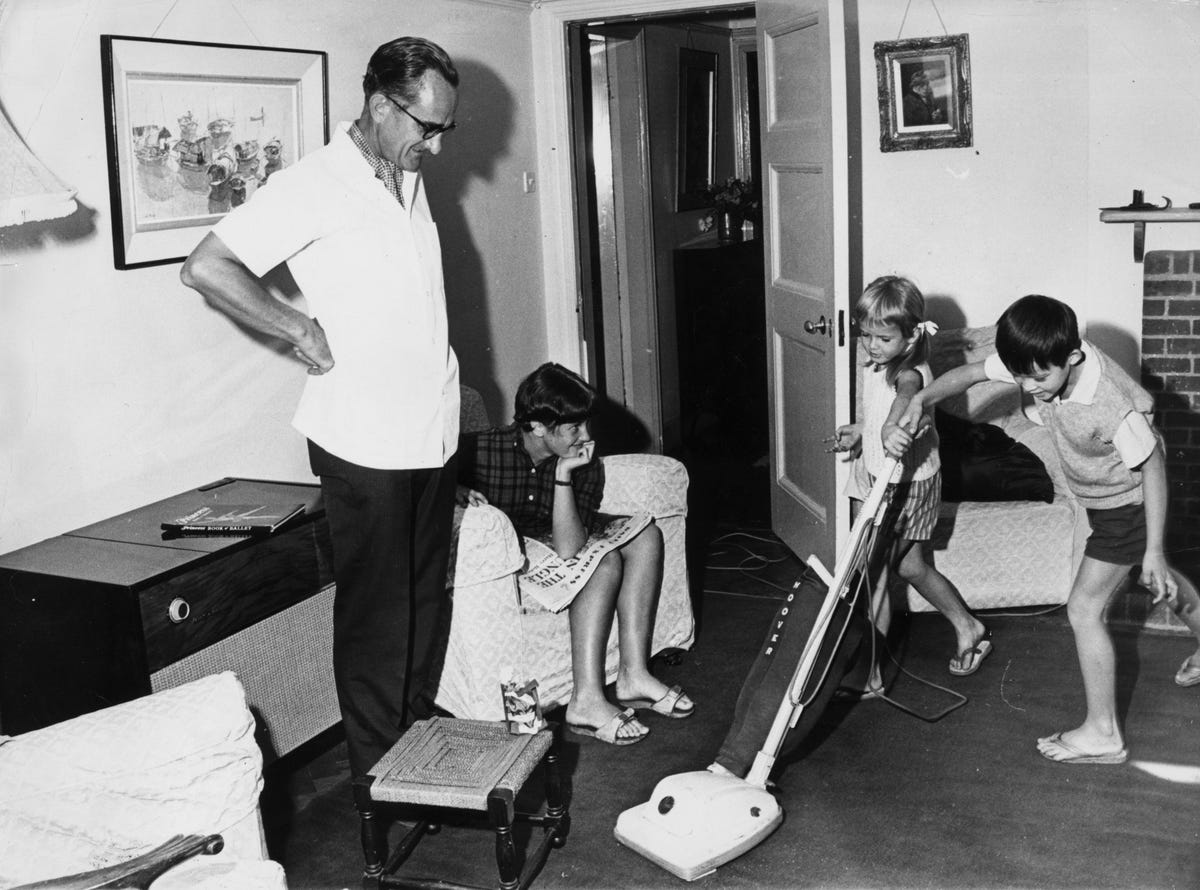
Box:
371 717 553 810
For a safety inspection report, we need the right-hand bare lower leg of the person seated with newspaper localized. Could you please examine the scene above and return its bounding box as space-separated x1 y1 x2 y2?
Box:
616 523 690 709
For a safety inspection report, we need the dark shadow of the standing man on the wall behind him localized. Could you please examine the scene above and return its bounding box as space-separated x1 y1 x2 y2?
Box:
422 59 514 413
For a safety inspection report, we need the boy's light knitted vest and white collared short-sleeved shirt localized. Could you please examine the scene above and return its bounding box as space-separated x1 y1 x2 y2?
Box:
984 341 1159 509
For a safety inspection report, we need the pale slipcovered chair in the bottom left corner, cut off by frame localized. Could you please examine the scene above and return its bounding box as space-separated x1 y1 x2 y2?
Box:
0 672 287 890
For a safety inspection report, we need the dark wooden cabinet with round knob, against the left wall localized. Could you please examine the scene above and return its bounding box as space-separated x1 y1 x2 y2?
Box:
0 479 340 757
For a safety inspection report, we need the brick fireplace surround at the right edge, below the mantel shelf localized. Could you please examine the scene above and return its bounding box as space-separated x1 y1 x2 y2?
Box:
1141 251 1200 582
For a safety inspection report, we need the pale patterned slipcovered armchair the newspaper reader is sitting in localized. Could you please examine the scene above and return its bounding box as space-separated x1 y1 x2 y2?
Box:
434 387 695 720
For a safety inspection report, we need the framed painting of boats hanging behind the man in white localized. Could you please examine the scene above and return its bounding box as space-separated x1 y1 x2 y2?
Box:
100 34 329 269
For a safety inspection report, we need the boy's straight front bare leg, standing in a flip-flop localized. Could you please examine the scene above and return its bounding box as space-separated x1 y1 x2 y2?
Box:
1038 557 1129 759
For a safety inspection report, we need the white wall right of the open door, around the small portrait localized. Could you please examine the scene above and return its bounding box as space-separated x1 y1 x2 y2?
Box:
858 0 1200 367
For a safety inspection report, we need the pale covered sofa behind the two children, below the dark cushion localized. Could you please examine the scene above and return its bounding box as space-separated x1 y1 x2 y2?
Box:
907 325 1090 612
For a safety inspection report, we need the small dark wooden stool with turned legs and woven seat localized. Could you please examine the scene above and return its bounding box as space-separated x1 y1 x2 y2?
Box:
354 717 570 890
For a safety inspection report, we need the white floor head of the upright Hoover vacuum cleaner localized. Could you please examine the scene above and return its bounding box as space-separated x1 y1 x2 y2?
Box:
613 770 784 880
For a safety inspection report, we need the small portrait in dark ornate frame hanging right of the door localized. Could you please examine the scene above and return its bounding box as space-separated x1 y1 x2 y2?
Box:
875 34 972 151
